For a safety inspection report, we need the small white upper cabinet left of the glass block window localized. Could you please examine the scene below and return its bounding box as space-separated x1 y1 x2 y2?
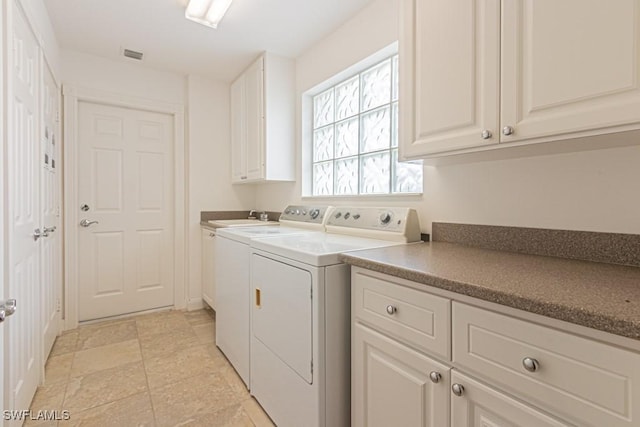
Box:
231 53 295 183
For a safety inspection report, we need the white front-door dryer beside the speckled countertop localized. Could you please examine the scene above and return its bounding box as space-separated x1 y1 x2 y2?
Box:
250 207 420 427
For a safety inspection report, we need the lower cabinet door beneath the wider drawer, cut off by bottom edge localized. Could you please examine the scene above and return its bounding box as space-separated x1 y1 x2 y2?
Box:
450 369 569 427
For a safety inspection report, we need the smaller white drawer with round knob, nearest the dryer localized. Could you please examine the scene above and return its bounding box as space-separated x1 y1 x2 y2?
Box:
351 270 451 360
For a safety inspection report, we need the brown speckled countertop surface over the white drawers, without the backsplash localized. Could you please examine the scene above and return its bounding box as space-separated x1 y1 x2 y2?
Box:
341 242 640 340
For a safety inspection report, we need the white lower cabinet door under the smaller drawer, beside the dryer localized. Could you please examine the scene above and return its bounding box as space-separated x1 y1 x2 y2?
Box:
351 322 450 427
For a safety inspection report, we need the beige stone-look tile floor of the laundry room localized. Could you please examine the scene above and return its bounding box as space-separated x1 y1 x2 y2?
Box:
25 310 273 427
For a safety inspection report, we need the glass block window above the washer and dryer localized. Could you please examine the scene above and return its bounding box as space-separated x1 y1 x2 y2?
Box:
312 55 422 196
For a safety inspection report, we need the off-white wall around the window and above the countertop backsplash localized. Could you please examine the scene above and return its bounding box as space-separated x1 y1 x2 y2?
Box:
256 0 640 234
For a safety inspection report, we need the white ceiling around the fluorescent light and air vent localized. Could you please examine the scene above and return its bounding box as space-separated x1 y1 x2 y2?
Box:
45 0 372 81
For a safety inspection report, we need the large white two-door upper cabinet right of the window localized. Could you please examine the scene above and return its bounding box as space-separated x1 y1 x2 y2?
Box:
400 0 640 159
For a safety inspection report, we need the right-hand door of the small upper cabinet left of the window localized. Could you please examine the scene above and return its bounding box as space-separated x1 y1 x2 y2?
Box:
245 58 265 180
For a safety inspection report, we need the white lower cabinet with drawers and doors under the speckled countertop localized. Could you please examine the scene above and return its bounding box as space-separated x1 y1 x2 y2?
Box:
351 267 640 427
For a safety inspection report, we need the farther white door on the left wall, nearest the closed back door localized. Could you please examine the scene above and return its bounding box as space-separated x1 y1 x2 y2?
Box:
40 61 62 360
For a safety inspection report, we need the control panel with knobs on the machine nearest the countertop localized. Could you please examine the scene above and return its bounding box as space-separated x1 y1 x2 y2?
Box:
326 206 420 242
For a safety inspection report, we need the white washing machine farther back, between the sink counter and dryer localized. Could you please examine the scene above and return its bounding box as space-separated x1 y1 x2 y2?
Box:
214 206 328 387
